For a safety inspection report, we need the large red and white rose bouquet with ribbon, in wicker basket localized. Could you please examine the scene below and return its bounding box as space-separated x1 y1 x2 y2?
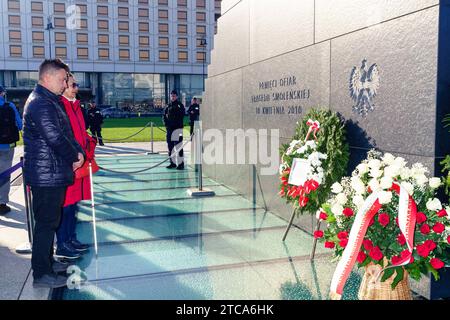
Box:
314 150 450 298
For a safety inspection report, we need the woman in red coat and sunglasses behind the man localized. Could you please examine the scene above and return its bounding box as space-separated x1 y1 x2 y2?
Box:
55 74 95 259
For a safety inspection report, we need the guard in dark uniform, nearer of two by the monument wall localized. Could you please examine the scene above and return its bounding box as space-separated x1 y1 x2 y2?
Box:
163 90 185 170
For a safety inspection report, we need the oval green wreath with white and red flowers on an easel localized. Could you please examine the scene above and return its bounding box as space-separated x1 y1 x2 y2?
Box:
279 109 349 213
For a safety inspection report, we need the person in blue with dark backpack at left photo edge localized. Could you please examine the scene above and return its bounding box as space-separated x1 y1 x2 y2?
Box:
0 86 22 215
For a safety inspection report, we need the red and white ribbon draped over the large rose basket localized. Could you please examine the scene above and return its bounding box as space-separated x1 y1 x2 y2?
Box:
330 183 417 299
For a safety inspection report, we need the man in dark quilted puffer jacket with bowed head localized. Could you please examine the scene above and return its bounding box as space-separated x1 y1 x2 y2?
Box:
23 59 84 288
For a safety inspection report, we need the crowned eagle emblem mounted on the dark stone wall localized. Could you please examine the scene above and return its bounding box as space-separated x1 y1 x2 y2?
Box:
350 59 380 117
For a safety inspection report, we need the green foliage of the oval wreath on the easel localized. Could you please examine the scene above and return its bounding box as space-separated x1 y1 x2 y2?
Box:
279 109 350 214
